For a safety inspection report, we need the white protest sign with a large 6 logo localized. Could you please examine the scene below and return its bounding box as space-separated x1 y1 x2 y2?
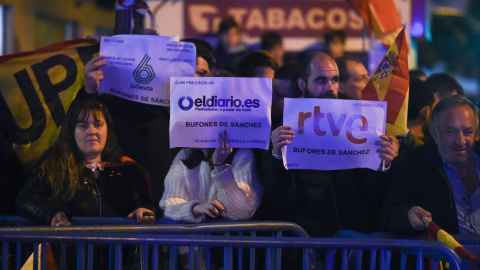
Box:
98 35 196 106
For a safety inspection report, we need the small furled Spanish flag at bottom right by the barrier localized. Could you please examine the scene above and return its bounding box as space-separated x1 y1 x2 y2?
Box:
423 218 480 269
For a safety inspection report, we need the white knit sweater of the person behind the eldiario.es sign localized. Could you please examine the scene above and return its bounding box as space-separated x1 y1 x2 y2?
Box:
160 148 262 222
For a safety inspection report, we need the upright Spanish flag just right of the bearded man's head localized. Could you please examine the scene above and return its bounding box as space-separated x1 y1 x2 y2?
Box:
362 29 410 136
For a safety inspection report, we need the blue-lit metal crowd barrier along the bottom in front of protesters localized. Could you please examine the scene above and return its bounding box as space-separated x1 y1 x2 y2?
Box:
0 218 460 270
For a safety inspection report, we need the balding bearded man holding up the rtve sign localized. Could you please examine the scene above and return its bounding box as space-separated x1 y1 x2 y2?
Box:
265 53 398 237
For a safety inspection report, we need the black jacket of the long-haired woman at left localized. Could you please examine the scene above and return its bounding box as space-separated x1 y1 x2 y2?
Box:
16 158 153 225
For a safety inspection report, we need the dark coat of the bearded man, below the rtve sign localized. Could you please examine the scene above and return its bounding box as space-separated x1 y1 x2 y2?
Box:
265 157 386 237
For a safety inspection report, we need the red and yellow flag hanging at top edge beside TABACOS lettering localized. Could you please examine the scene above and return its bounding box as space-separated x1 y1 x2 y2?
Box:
347 0 402 48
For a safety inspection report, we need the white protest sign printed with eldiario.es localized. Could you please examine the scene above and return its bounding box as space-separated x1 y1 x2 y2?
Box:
170 77 272 149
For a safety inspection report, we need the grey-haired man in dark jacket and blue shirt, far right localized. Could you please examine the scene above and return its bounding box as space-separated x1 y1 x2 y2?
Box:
380 96 480 236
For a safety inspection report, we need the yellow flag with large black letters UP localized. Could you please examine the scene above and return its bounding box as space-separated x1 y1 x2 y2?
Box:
0 39 99 169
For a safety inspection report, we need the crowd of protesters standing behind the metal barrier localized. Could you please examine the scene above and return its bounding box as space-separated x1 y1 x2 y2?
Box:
0 15 480 268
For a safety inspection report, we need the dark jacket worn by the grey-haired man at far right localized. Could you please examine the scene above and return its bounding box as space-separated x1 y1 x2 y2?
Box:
380 140 458 236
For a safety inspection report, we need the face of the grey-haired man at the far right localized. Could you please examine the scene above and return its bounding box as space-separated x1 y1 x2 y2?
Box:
430 106 477 166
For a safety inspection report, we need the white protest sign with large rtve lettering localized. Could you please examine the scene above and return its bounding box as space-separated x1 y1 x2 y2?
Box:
282 98 387 170
